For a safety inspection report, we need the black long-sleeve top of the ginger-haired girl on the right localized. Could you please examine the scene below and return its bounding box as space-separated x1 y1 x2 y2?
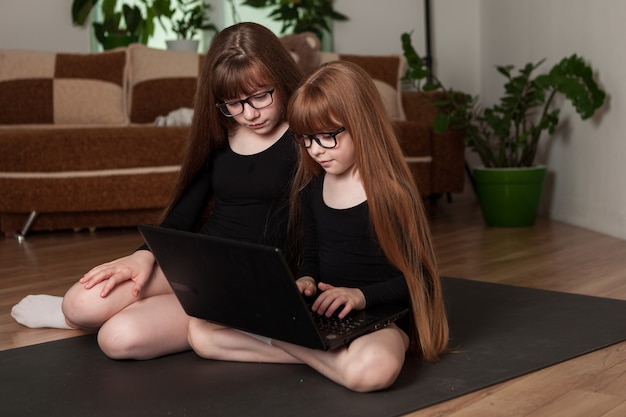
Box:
298 178 409 306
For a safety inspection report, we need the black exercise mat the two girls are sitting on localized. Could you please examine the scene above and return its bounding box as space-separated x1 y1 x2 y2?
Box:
0 278 626 417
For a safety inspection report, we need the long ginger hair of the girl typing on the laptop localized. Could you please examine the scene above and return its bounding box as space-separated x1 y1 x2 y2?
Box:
288 61 448 361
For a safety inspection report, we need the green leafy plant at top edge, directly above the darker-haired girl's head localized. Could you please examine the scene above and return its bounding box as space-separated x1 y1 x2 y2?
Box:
241 0 348 49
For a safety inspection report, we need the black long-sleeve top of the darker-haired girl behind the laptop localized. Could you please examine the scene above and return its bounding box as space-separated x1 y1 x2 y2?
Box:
142 131 297 251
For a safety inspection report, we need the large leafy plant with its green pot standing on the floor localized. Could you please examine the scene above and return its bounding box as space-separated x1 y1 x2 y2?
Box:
401 33 606 227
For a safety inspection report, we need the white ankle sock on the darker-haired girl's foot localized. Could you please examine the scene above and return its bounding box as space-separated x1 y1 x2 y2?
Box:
11 294 71 329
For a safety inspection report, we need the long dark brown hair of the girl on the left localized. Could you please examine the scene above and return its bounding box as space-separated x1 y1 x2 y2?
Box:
162 22 302 224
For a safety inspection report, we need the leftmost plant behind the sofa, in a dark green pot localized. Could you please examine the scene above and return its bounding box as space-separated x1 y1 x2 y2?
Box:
72 0 170 50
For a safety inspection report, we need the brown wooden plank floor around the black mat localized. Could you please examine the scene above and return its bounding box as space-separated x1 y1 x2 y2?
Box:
0 191 626 417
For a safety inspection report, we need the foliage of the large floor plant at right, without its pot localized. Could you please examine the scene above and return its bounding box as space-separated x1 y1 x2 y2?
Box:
401 33 606 167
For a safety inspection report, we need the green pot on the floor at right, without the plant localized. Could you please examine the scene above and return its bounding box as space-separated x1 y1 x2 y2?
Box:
474 166 547 227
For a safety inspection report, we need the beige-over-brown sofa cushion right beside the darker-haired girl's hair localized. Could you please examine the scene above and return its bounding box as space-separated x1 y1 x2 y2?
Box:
128 44 203 123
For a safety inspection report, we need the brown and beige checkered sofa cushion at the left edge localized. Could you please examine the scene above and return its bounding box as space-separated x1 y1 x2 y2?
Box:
0 50 128 125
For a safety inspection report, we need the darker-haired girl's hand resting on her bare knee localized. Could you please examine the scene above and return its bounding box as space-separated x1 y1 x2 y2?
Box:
79 250 154 297
